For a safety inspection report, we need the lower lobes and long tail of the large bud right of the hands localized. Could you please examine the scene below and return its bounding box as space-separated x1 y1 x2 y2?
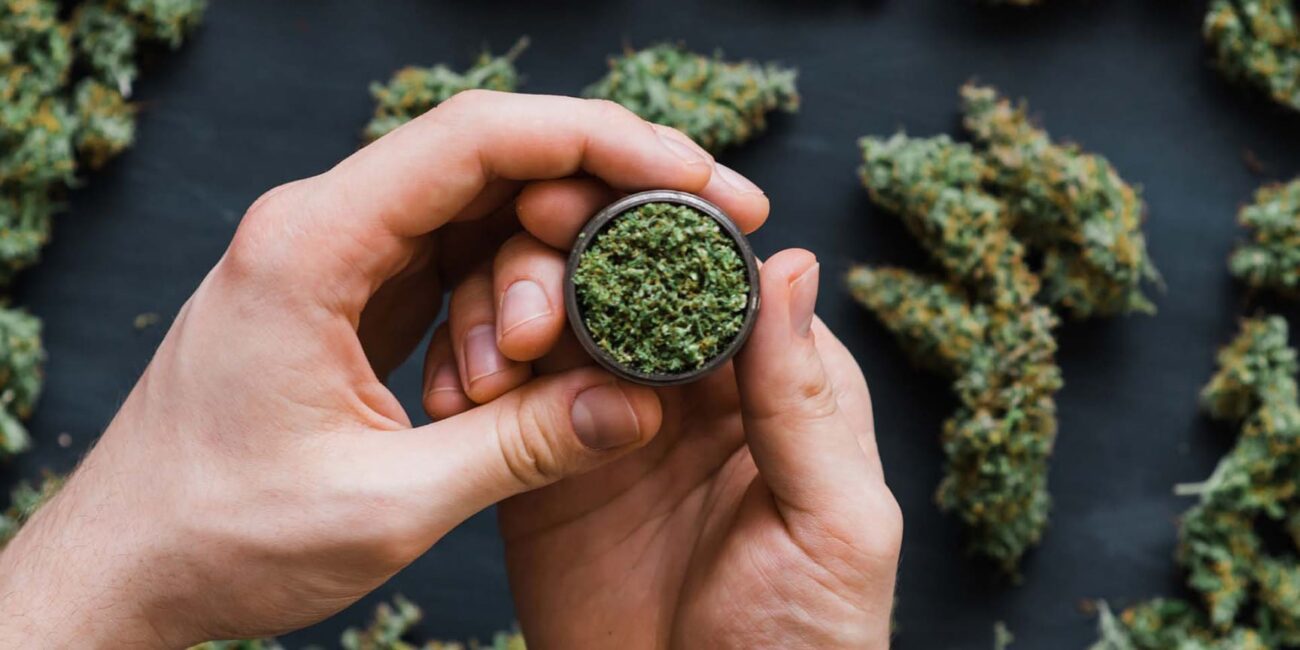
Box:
848 267 1061 573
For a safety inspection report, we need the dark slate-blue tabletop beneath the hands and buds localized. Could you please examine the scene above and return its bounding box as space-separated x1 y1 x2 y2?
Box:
3 0 1300 649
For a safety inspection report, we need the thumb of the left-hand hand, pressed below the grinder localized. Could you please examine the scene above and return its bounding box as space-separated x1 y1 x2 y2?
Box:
379 368 662 525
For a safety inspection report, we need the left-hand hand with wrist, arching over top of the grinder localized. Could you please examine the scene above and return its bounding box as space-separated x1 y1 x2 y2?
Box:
0 92 767 647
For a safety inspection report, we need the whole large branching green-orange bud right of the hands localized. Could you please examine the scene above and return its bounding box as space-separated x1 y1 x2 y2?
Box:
848 85 1156 573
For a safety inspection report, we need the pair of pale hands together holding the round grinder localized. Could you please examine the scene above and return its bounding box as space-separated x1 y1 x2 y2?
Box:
0 92 902 650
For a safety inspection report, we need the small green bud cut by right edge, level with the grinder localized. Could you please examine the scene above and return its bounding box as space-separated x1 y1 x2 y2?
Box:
1229 178 1300 296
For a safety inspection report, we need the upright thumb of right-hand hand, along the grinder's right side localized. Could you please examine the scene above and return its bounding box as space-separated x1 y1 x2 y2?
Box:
736 250 870 514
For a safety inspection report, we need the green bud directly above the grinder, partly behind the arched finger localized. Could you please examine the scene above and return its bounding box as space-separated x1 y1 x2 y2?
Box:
584 43 800 152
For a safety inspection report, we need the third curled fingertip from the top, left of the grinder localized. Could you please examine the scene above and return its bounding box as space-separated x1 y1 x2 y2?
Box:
447 267 529 404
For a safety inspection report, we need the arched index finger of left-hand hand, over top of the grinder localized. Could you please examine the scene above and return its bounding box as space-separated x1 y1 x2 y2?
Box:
229 91 712 313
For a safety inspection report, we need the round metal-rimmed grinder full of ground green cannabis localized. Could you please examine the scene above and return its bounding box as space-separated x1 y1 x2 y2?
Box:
566 190 758 385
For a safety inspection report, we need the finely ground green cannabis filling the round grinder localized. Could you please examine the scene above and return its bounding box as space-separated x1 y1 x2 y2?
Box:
573 203 749 374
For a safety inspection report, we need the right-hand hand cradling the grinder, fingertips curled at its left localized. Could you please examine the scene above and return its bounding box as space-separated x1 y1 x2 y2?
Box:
436 205 902 642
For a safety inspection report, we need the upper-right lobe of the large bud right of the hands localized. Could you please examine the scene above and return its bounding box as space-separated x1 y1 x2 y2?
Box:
961 85 1158 317
